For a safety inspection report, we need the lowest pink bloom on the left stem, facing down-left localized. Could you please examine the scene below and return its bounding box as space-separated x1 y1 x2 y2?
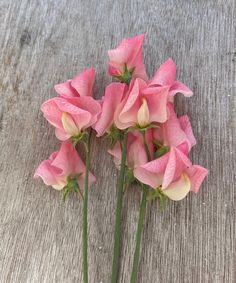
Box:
34 142 96 190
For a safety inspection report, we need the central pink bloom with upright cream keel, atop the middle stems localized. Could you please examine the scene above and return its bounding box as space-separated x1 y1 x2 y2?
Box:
114 79 168 130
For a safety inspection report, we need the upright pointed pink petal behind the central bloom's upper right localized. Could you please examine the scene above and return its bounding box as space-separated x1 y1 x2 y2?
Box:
149 58 176 86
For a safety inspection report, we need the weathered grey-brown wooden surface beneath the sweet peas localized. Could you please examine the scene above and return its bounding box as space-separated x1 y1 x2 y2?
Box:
0 0 236 283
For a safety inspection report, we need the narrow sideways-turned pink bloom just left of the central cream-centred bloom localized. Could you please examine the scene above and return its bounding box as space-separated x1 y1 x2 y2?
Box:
94 83 127 137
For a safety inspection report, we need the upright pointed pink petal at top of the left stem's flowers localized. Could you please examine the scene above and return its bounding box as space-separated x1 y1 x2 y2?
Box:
71 68 95 96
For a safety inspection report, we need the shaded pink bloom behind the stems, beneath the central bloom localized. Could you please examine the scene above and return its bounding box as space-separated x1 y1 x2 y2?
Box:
108 130 154 170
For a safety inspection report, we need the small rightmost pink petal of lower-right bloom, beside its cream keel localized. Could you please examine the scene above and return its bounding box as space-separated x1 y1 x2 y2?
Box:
186 165 208 193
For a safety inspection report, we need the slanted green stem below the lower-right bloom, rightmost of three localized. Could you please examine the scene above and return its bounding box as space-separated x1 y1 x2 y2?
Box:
130 186 148 283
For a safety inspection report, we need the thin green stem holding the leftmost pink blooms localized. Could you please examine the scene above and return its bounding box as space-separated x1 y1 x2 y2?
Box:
83 132 91 283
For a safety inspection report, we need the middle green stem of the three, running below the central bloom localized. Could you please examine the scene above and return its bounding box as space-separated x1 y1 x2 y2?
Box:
111 131 127 283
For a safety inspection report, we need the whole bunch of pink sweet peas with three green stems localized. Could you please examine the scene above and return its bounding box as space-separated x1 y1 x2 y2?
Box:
35 35 208 283
